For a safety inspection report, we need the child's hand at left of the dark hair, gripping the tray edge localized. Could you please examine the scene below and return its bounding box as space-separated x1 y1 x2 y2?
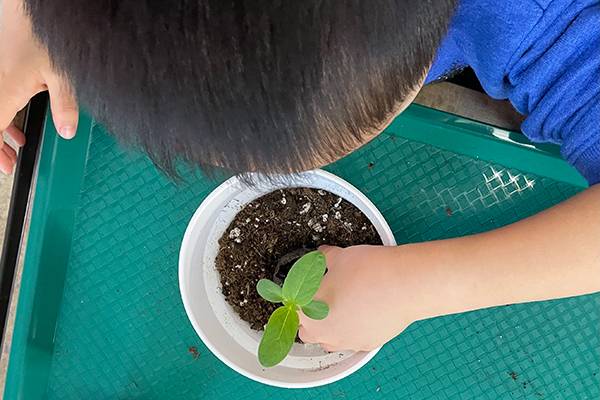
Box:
0 0 78 173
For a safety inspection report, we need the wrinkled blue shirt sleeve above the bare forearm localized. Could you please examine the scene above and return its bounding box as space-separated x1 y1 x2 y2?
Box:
505 2 600 184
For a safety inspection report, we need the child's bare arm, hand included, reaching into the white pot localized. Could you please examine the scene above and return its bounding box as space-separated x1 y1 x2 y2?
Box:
300 185 600 350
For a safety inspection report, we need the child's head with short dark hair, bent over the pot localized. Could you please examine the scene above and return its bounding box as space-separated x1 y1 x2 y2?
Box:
24 0 456 172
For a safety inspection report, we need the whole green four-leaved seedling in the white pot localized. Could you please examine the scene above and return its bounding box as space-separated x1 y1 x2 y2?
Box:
256 251 329 368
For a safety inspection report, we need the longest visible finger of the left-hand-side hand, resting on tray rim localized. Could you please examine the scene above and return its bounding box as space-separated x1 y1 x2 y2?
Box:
48 78 79 139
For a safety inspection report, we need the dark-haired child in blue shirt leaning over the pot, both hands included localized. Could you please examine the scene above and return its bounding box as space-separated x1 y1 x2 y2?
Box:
0 0 600 350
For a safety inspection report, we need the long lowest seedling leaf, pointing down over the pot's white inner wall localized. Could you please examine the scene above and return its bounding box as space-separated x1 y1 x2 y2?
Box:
258 306 300 368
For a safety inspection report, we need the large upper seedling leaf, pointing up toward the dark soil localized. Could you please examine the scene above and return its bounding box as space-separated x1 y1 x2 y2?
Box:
282 251 326 307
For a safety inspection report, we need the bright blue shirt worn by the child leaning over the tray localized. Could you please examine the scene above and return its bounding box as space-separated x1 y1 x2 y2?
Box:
426 0 600 184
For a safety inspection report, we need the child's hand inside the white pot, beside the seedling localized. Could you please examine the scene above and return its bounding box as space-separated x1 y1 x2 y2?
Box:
300 246 415 351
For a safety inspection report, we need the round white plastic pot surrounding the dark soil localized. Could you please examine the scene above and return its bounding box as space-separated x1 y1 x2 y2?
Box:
179 170 396 388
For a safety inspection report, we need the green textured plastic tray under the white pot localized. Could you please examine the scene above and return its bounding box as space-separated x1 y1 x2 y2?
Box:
4 106 600 400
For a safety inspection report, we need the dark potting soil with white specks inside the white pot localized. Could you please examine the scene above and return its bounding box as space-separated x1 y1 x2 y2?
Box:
216 188 382 330
